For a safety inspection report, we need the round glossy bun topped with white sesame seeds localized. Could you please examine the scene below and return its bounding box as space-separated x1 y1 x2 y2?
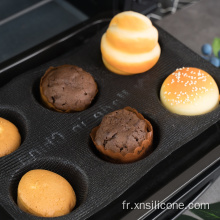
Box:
160 67 219 115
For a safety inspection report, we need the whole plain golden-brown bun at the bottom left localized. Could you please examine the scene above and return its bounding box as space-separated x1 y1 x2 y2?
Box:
17 169 76 217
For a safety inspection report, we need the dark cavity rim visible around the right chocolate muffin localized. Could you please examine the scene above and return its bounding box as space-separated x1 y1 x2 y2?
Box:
88 114 160 164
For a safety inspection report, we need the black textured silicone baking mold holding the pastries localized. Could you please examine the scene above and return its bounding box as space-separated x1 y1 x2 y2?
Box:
0 22 220 219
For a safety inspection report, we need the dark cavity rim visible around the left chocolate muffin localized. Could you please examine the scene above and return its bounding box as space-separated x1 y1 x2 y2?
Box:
32 77 100 114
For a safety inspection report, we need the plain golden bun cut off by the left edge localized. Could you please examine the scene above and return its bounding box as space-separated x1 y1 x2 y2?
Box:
0 118 21 157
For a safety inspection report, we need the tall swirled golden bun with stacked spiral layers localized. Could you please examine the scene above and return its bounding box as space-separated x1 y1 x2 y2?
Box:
101 11 161 75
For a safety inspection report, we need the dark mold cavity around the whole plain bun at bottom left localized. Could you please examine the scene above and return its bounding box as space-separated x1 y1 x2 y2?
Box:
9 158 88 216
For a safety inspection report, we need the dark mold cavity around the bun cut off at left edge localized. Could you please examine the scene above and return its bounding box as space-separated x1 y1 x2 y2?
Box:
0 108 28 149
